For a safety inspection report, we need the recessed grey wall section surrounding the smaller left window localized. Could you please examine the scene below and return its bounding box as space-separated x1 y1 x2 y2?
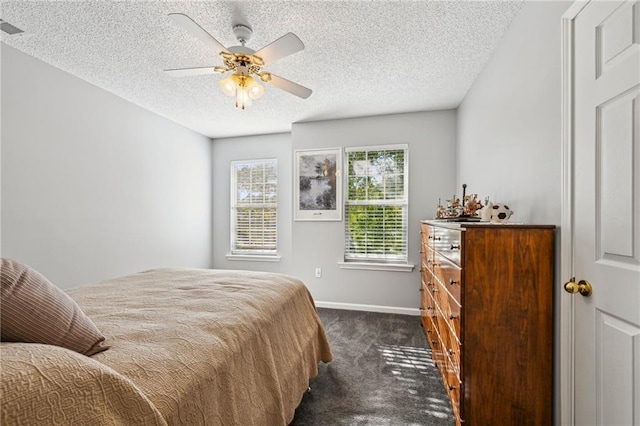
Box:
212 133 293 273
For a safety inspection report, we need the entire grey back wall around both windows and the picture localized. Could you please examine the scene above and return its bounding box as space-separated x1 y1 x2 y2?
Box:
212 110 456 311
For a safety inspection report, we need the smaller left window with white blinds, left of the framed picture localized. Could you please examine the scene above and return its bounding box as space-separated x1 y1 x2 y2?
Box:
231 159 278 255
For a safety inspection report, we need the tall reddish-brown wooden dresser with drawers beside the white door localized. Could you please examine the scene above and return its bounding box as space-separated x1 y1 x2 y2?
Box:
420 221 555 426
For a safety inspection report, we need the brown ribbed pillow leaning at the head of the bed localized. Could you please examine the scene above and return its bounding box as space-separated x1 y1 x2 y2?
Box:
0 258 109 356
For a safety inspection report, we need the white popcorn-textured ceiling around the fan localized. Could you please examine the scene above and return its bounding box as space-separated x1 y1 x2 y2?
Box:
0 0 522 138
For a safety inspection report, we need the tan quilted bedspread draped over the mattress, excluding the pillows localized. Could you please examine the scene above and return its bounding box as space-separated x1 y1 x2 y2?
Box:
2 269 331 425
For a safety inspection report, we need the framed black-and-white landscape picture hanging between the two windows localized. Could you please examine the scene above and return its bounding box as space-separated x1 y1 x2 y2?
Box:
293 148 342 220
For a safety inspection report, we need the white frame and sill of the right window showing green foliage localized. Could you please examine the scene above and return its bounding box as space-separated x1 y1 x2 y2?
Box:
339 144 414 272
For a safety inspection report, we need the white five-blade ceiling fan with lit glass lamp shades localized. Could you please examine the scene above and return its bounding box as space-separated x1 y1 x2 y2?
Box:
165 13 311 109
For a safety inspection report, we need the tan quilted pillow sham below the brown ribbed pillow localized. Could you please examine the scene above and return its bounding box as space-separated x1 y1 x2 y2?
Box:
0 343 166 426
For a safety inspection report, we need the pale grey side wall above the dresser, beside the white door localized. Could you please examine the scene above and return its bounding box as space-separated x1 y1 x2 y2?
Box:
457 1 570 224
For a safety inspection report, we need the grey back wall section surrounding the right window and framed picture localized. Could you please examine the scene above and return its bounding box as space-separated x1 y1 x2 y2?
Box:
290 110 456 309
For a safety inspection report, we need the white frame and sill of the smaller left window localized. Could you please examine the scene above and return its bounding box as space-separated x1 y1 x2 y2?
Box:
226 158 280 262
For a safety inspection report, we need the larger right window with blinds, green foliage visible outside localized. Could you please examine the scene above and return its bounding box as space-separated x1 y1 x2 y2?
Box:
345 145 409 263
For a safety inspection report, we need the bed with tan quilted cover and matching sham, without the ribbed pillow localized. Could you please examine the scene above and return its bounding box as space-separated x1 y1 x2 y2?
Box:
0 262 332 426
